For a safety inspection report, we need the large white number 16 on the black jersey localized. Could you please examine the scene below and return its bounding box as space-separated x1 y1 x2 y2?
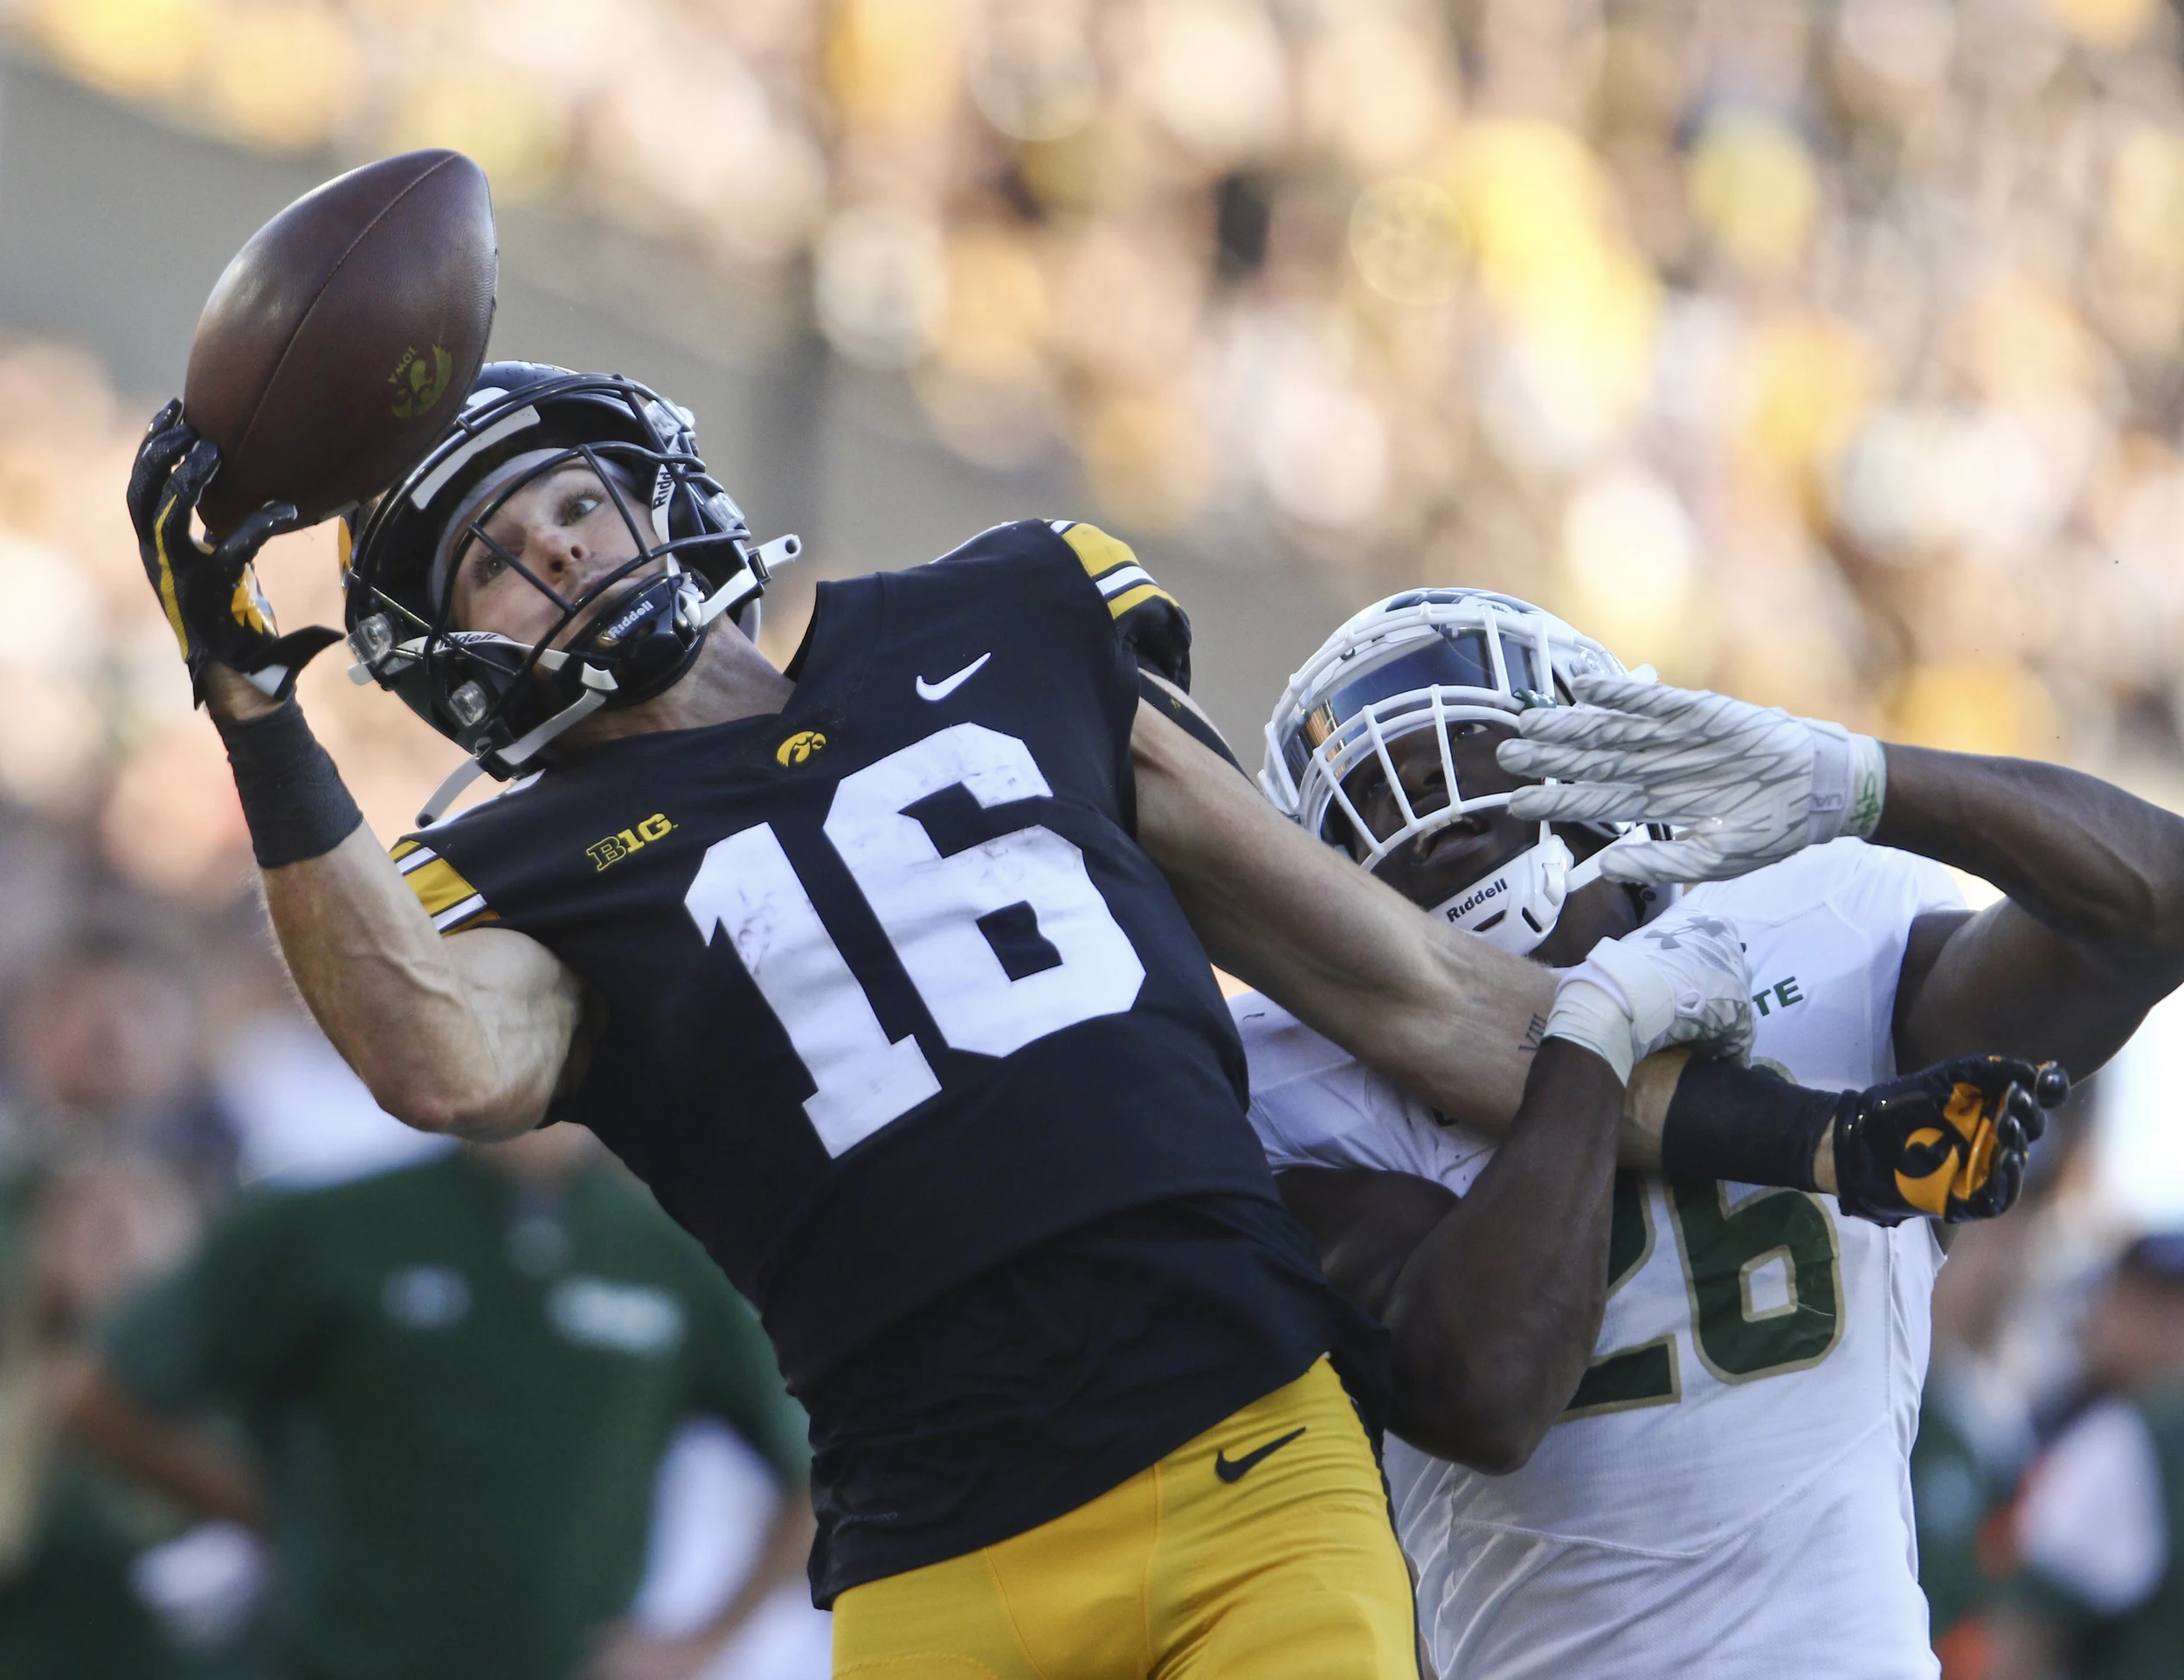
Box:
684 723 1144 1156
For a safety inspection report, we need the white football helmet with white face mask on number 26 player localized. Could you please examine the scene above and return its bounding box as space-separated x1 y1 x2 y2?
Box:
1258 590 1667 955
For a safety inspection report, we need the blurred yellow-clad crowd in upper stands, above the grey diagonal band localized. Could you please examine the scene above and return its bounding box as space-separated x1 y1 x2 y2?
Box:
21 0 2184 791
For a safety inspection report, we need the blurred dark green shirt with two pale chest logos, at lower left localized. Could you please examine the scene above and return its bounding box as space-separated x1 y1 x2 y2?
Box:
109 1153 808 1680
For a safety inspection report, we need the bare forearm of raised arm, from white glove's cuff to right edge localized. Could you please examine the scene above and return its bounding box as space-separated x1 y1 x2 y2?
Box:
1874 745 2184 955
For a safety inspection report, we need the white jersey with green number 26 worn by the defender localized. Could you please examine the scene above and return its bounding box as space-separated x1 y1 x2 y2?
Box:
1232 839 1961 1680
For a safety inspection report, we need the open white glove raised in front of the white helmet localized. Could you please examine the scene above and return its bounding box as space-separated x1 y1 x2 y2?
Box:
1496 677 1890 882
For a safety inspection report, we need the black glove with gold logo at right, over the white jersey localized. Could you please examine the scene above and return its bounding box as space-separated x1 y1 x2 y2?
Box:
1835 1055 2070 1226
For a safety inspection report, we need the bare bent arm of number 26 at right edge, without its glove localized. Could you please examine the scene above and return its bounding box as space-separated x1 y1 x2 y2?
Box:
1874 745 2184 1077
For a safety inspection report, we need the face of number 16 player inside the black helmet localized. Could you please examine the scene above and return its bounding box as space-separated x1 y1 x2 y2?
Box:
454 463 658 645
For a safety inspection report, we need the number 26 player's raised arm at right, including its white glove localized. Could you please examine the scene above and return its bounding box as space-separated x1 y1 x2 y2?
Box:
1498 677 2184 1075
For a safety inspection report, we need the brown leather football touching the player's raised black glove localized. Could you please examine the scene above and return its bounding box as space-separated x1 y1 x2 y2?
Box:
182 151 498 533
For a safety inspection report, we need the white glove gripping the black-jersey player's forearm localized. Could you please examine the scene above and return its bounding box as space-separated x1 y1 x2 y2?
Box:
1546 911 1752 1083
